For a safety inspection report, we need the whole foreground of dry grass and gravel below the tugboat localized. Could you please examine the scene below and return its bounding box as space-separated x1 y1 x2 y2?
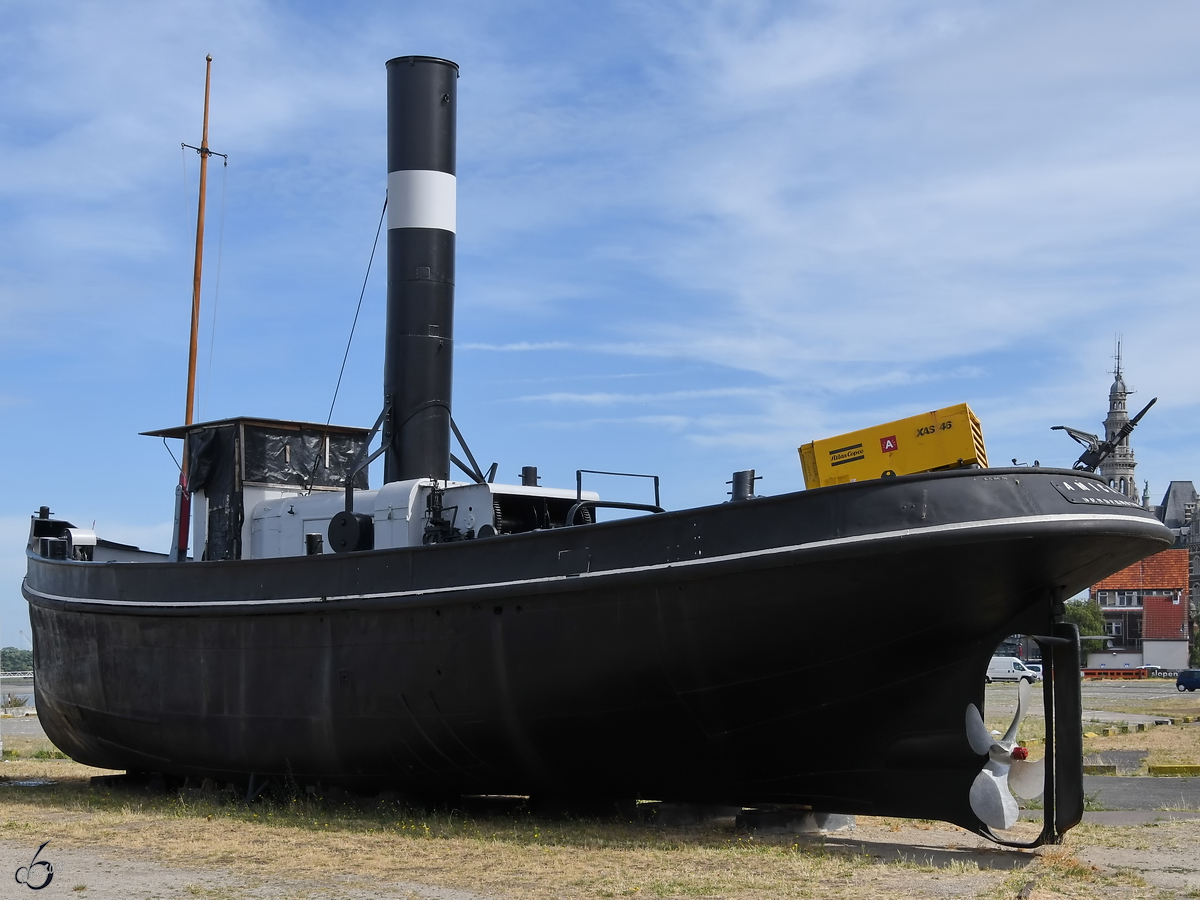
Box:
0 760 1200 900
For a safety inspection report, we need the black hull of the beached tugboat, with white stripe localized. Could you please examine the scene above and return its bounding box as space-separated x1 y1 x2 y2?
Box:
24 469 1170 827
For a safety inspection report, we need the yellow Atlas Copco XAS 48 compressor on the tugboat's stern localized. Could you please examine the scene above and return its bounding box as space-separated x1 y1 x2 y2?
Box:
799 403 988 487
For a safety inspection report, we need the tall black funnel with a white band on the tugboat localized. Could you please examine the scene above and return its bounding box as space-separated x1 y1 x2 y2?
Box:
383 56 458 481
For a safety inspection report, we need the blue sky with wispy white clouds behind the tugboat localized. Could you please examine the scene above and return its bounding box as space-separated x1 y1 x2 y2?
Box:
0 0 1200 646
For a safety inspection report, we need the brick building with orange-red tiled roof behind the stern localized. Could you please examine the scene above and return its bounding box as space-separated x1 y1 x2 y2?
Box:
1088 548 1189 670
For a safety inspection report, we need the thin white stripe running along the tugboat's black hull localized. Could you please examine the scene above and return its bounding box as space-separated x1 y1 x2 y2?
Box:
23 512 1156 610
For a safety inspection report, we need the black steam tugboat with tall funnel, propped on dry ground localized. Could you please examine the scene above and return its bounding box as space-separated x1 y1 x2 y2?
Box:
23 56 1171 845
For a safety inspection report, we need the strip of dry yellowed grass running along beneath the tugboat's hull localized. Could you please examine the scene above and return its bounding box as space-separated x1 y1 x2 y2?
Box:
0 760 1060 900
